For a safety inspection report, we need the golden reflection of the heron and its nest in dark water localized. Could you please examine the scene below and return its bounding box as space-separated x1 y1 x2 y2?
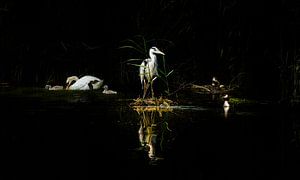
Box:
134 106 172 164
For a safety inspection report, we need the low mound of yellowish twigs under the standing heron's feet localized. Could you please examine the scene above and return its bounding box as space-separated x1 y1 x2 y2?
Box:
130 97 177 107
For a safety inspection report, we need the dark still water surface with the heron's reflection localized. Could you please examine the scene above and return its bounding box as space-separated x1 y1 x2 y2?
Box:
1 90 300 179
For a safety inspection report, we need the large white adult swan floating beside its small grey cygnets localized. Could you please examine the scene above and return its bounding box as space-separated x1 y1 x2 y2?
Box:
66 75 103 90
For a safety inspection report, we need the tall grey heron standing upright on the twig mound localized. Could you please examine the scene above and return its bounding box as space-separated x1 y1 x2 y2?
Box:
139 47 165 97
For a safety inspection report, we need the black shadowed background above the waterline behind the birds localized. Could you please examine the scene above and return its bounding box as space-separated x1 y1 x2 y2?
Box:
0 0 300 100
